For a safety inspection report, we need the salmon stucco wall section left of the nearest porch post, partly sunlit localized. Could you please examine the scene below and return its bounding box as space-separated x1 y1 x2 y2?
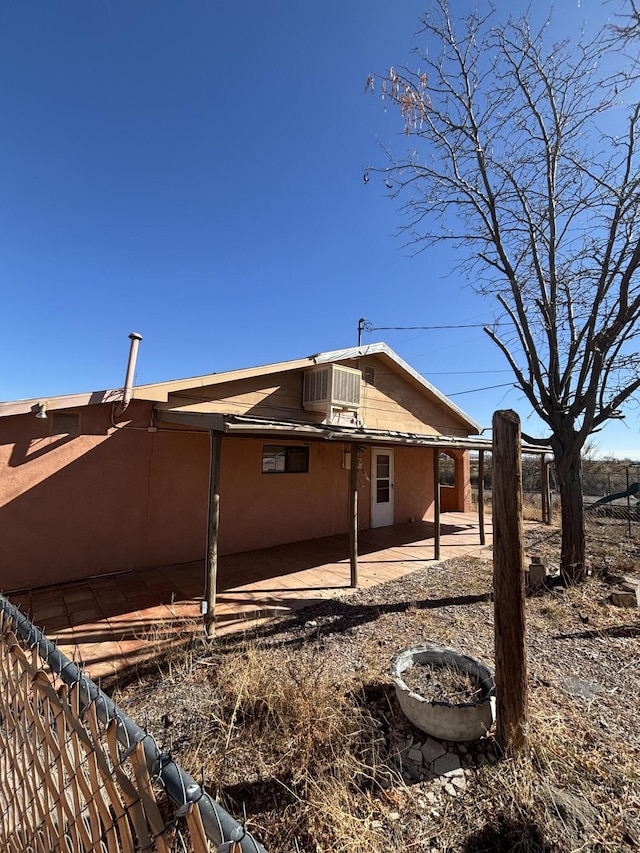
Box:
0 403 209 590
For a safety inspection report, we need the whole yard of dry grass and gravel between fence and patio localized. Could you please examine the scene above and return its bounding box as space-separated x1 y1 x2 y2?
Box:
118 516 640 853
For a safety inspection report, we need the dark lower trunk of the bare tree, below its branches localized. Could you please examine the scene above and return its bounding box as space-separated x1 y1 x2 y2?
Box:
554 447 586 583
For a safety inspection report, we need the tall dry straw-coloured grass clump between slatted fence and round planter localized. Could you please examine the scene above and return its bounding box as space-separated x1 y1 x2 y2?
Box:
189 645 389 851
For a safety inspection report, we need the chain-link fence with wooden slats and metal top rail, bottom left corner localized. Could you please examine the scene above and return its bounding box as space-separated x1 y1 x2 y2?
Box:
0 596 266 853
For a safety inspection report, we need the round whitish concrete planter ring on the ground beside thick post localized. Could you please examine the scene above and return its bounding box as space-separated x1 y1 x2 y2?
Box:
391 643 496 741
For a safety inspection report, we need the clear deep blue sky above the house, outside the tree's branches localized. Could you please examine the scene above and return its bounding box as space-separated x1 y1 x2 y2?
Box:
0 0 640 458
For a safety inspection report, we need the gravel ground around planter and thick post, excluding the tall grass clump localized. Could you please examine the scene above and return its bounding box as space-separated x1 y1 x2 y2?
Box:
116 525 640 851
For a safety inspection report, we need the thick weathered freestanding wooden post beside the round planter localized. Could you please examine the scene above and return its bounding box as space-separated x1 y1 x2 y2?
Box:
492 411 528 753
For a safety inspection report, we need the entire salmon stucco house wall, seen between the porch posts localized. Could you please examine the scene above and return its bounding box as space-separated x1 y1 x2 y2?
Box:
0 401 470 591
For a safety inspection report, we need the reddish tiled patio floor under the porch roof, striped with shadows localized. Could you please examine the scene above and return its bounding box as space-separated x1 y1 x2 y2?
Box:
9 513 492 679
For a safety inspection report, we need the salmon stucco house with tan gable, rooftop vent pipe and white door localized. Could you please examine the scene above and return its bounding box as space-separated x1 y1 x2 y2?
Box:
0 335 490 591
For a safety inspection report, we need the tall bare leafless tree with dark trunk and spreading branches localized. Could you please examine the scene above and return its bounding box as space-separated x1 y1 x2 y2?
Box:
367 0 640 581
